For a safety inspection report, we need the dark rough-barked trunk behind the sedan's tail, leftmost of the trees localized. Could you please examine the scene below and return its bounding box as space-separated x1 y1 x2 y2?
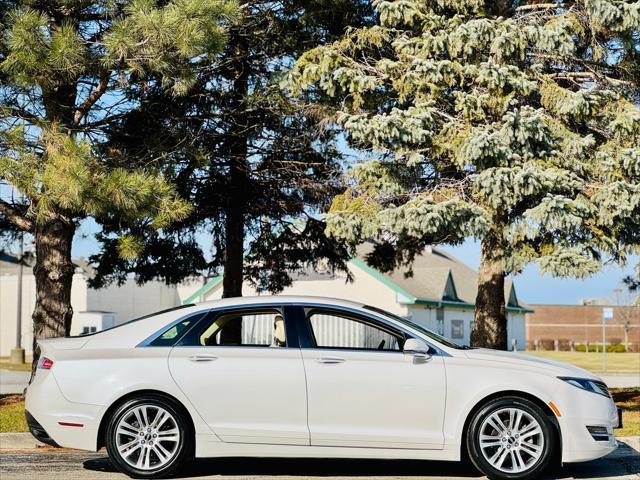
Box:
31 217 76 377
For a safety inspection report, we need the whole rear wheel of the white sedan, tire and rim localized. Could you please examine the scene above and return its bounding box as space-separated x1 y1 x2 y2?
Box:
105 395 192 478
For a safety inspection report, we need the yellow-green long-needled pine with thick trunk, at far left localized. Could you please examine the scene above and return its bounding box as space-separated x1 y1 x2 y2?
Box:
0 0 237 372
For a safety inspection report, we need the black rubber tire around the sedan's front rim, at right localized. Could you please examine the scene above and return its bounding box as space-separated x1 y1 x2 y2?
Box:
466 397 557 480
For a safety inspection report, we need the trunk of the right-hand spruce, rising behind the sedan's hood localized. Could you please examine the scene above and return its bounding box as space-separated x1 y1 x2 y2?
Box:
471 230 507 350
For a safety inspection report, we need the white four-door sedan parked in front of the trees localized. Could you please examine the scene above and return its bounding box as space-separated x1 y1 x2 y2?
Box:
26 296 619 480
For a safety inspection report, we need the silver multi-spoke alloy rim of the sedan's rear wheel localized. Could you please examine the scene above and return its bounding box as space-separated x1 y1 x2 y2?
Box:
115 405 180 470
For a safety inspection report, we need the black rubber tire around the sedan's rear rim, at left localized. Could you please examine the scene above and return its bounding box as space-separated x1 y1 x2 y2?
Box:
104 394 194 478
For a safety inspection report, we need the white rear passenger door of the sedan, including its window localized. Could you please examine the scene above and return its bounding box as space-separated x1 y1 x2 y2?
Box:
169 307 309 445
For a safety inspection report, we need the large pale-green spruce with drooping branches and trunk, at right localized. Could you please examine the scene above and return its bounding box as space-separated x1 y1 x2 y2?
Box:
288 0 640 349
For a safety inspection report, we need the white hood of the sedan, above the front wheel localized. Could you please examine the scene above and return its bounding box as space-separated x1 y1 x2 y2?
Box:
465 348 600 380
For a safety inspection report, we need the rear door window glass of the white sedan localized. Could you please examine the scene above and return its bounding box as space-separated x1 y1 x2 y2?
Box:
196 310 287 347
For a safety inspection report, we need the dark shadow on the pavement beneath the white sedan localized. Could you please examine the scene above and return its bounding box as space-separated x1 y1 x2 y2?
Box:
84 456 639 479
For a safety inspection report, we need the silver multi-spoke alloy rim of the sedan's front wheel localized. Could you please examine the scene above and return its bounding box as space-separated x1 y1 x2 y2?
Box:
479 408 544 473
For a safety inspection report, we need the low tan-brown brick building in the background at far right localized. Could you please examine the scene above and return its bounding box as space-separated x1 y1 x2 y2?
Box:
526 305 640 351
